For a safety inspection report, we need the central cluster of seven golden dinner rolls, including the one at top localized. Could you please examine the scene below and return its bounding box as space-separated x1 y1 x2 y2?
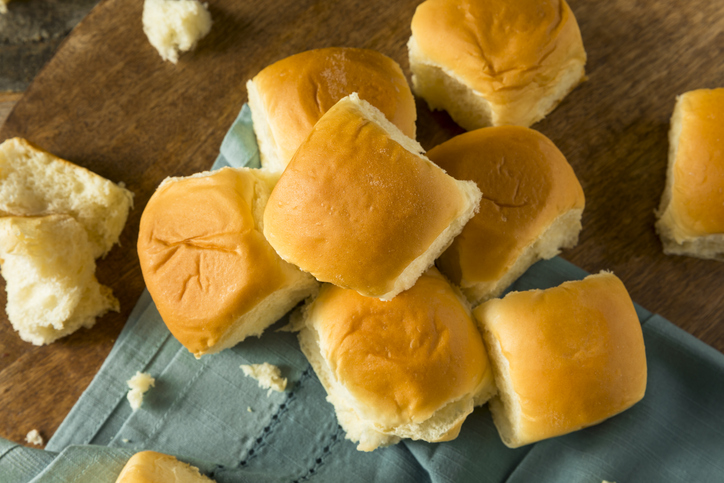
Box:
138 0 646 451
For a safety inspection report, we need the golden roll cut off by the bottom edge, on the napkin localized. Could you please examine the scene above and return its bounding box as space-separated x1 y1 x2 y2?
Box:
116 451 214 483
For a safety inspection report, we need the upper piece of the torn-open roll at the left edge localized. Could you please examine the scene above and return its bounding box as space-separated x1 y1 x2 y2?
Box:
0 138 133 258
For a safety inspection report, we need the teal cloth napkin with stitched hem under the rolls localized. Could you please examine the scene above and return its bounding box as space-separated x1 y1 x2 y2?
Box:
0 106 724 483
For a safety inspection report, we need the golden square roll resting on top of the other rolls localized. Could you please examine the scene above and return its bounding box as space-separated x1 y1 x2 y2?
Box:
264 94 481 300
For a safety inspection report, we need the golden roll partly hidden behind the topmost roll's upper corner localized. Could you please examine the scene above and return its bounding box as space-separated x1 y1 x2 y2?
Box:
246 48 417 173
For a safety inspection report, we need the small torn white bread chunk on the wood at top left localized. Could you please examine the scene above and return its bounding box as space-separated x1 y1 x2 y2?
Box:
142 0 211 64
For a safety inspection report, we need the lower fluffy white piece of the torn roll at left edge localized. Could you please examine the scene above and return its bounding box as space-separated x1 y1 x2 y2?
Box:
0 215 119 345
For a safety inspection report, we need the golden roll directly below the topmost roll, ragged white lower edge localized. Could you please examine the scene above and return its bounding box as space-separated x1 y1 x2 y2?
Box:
299 268 495 451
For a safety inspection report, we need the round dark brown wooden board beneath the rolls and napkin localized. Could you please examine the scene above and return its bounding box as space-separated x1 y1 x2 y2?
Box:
0 0 724 442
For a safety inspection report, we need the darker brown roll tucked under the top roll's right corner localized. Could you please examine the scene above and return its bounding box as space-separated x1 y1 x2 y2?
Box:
427 126 585 304
